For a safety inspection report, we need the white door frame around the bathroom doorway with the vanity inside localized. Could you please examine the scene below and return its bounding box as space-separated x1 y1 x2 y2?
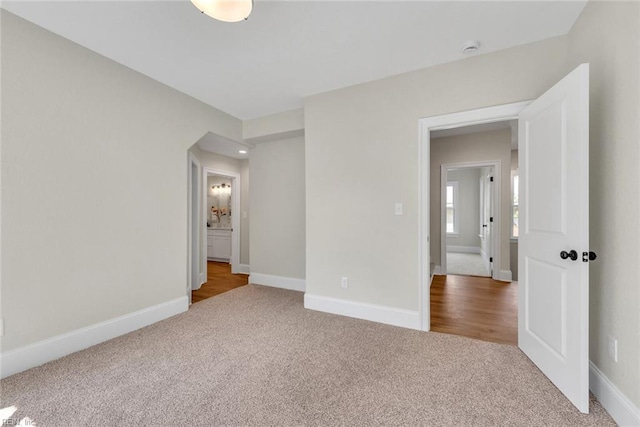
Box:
200 168 242 274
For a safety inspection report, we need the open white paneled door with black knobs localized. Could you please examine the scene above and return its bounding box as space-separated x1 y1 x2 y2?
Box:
518 64 589 413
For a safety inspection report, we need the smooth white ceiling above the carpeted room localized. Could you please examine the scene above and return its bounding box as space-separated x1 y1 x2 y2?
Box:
2 0 586 120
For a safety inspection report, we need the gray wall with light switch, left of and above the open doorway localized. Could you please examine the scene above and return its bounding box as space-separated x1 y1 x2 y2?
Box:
306 37 567 311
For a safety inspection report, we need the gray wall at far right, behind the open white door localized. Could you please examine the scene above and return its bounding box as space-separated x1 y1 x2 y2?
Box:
568 1 640 407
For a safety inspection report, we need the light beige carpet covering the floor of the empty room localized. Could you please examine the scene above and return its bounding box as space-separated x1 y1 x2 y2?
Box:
0 285 615 426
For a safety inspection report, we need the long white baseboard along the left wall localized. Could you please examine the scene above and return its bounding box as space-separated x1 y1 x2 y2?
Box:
0 295 189 378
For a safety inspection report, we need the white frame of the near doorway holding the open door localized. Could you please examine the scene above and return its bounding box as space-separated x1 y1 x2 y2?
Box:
418 101 532 331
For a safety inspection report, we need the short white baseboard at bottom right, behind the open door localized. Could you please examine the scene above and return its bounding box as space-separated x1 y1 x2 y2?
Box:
589 362 640 427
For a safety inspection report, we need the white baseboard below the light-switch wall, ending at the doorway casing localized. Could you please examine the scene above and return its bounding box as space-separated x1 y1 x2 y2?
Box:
304 293 421 330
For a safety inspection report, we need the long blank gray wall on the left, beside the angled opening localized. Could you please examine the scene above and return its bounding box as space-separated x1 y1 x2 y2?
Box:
0 10 242 352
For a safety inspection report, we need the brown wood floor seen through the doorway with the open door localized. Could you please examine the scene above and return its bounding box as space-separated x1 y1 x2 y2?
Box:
431 275 518 345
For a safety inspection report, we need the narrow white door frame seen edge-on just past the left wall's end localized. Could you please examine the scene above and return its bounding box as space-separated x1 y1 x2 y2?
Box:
186 152 202 305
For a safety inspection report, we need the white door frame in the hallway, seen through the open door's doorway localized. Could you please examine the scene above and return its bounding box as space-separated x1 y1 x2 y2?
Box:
440 160 502 280
